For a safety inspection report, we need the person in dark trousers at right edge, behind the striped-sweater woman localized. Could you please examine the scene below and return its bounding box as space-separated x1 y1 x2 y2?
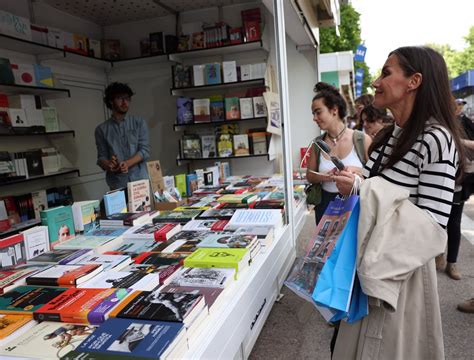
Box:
436 99 474 280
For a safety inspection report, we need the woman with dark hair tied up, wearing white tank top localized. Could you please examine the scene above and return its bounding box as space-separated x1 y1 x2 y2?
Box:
306 82 372 224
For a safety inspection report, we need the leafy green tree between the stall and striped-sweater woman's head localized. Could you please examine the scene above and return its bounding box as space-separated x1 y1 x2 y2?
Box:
319 4 372 94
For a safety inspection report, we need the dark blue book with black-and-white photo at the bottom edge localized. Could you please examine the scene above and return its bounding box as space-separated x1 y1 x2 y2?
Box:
77 318 184 359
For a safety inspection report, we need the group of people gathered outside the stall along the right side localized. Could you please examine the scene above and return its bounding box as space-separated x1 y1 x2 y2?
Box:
307 46 474 359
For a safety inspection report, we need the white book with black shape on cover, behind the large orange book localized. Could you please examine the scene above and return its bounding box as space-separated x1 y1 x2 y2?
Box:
78 271 160 291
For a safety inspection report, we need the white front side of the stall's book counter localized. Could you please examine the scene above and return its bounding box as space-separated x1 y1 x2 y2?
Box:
184 225 294 359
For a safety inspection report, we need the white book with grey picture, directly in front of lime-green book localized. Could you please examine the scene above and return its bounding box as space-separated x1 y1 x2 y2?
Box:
170 267 235 289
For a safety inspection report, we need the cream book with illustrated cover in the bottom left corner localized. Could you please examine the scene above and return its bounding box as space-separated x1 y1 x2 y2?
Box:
0 321 95 359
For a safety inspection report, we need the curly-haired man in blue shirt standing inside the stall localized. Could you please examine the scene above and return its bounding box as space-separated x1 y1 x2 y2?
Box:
95 82 150 190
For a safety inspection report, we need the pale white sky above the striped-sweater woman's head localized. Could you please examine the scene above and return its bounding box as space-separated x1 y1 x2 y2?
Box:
351 0 474 73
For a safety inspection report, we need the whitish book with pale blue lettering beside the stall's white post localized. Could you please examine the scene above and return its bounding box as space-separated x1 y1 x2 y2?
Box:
225 209 283 230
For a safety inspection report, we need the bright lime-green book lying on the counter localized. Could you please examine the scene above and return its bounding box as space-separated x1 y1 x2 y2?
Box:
184 248 250 272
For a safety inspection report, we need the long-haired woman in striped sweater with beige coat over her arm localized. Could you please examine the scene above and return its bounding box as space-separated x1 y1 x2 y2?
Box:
334 46 464 359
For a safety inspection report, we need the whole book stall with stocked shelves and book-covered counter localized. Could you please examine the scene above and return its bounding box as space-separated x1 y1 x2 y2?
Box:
0 0 334 359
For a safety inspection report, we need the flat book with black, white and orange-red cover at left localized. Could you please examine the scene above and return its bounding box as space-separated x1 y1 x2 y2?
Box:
26 264 103 286
